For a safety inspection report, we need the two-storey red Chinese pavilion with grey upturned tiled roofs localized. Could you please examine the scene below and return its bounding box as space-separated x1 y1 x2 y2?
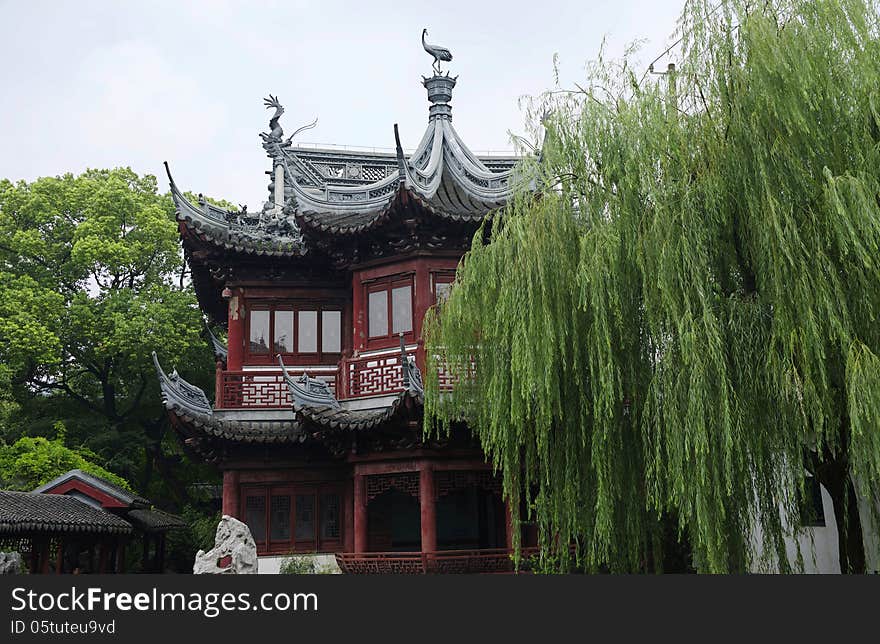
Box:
154 45 531 572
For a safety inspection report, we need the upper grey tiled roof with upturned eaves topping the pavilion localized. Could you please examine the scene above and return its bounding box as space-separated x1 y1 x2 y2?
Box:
166 69 527 257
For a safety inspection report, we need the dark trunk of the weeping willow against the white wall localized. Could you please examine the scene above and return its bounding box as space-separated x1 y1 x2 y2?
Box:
816 460 866 575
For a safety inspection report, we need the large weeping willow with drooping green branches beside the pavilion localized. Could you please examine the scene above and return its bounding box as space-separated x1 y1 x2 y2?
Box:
426 0 880 572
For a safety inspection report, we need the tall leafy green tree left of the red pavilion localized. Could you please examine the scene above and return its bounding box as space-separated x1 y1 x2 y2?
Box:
0 168 212 504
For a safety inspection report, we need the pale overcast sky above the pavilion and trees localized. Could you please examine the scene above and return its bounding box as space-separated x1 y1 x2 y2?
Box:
0 0 683 210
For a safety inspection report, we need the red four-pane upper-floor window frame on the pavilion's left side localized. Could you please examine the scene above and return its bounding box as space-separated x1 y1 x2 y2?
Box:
244 301 345 365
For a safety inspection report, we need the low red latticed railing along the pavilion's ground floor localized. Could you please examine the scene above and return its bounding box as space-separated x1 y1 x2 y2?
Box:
336 548 537 575
